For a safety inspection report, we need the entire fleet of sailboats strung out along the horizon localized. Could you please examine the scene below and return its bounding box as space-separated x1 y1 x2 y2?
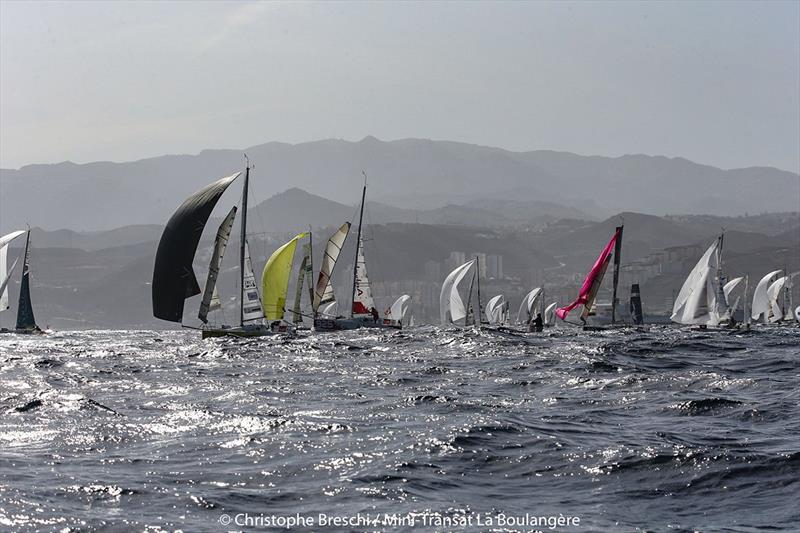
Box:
0 162 800 338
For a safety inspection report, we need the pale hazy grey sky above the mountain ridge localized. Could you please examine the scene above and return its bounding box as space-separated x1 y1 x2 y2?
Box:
0 0 800 172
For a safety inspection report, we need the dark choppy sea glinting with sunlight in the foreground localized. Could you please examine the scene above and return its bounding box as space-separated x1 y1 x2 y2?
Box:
0 328 800 531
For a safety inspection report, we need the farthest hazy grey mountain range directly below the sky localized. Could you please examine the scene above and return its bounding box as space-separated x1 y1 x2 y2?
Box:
0 137 800 230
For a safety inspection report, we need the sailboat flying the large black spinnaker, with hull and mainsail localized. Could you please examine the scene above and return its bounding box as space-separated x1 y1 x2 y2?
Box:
152 162 286 338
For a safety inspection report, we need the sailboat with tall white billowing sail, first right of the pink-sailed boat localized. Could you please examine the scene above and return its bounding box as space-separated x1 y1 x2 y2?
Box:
670 235 730 328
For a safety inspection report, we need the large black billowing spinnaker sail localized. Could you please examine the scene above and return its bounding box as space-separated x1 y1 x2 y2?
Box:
152 172 239 322
